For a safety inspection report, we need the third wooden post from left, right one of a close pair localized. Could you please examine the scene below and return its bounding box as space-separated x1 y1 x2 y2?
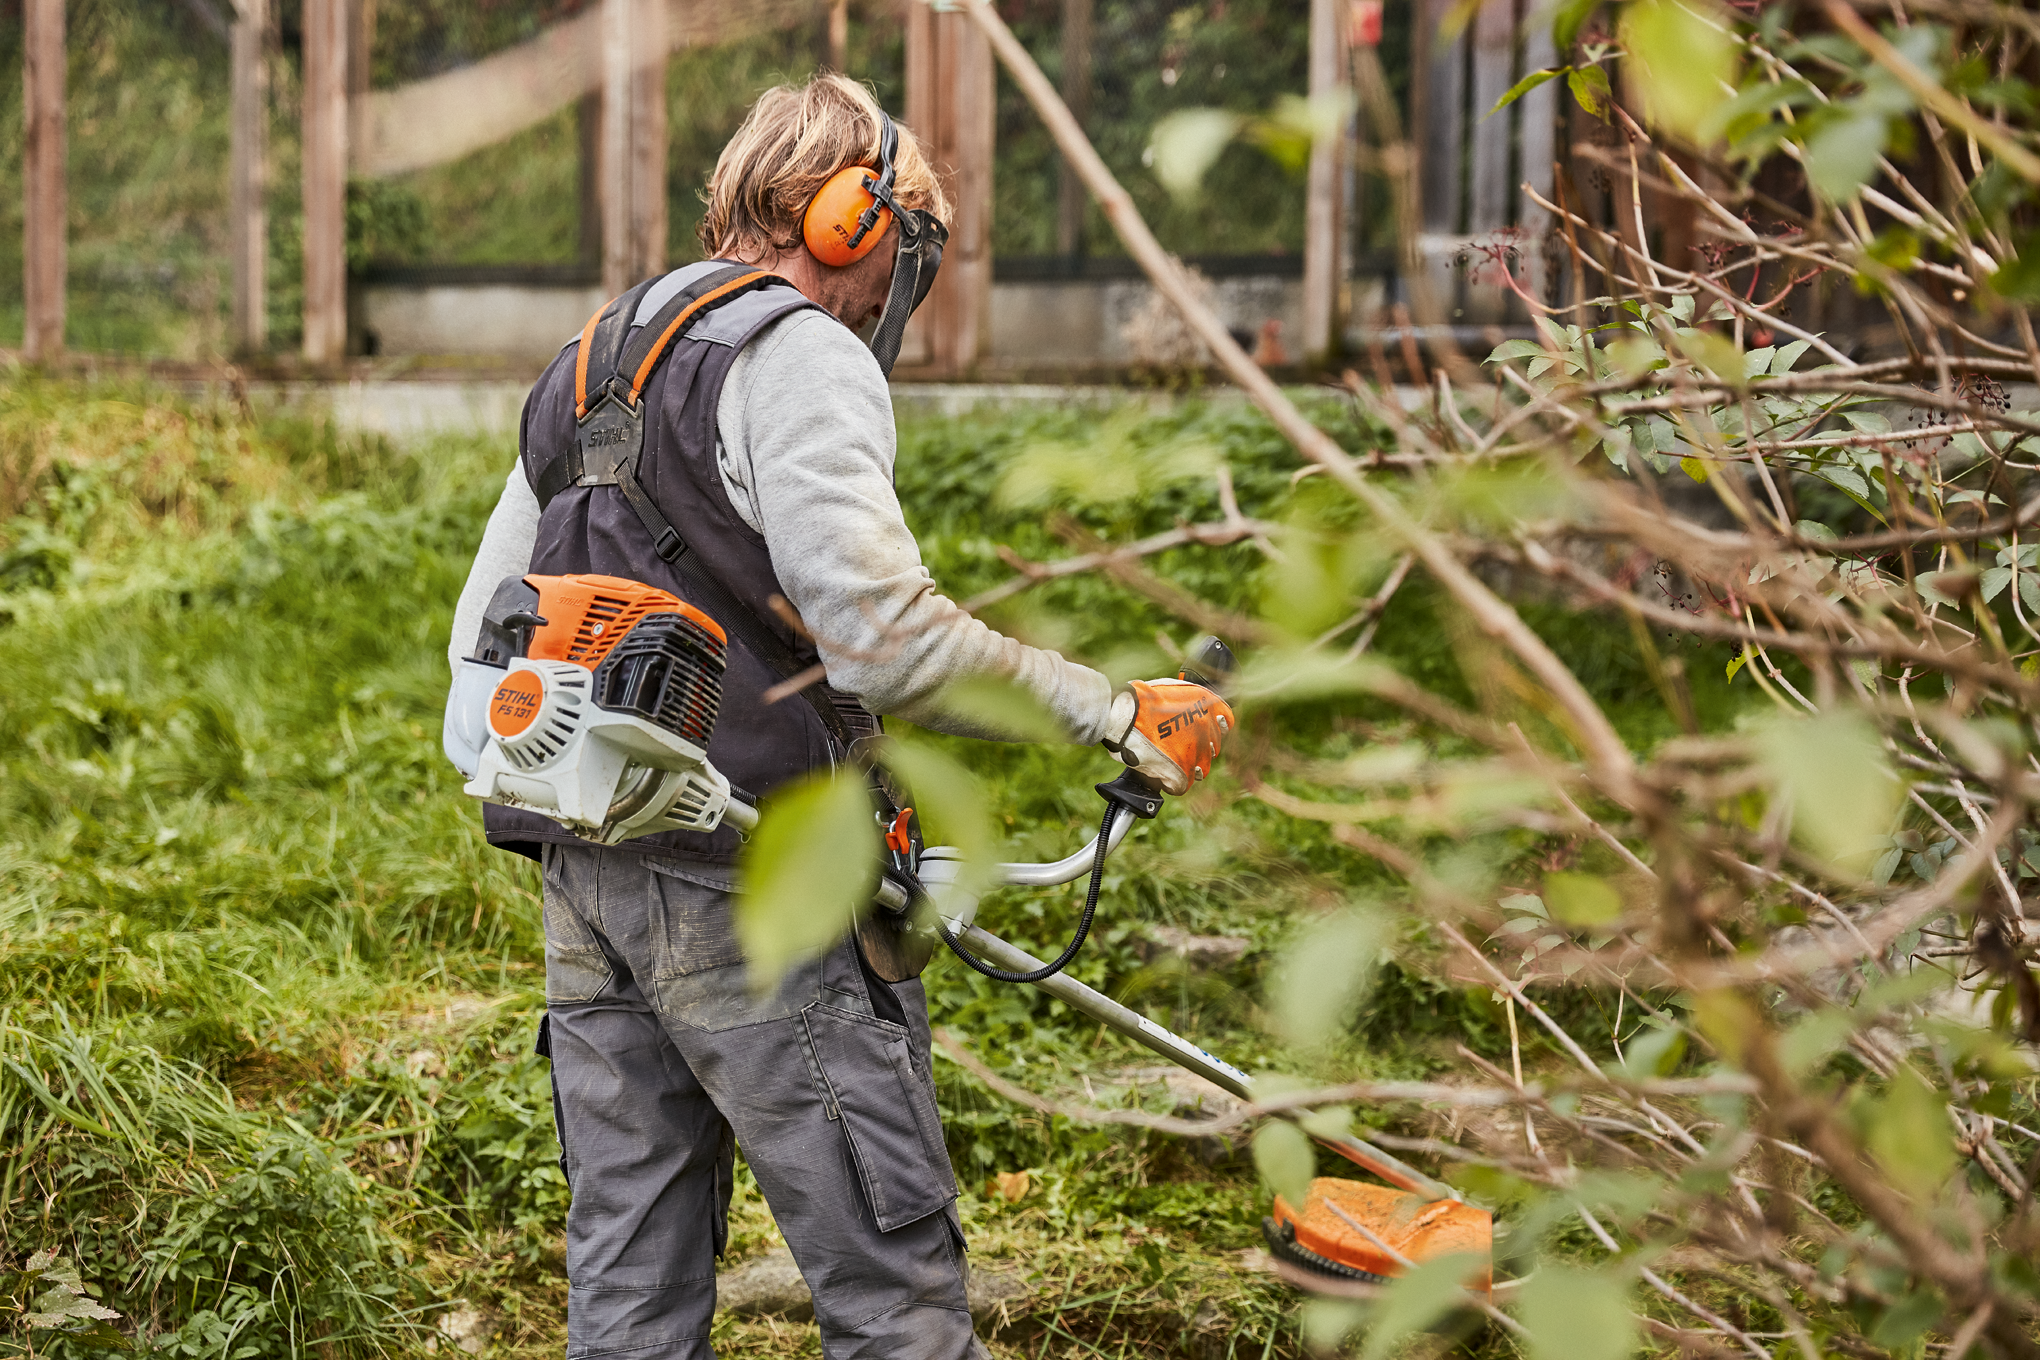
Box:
304 0 349 365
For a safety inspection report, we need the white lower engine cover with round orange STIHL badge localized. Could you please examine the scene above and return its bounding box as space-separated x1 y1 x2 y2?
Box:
445 657 755 846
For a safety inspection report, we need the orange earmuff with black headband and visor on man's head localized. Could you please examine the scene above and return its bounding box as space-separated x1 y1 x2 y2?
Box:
800 110 949 373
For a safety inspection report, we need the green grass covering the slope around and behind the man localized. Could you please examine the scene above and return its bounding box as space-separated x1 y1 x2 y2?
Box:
0 373 1770 1356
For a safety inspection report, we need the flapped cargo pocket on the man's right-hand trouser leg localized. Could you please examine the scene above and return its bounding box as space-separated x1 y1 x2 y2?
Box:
800 1003 957 1232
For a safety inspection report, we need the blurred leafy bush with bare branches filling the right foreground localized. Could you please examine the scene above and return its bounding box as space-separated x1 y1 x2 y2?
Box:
957 0 2040 1358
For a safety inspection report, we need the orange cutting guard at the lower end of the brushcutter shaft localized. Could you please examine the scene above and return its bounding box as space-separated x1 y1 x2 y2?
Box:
1275 1176 1495 1293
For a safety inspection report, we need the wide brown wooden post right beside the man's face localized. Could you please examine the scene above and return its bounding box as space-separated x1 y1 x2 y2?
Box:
902 0 998 375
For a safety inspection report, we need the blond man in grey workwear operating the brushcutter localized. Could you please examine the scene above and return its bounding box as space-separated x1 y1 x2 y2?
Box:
449 75 1216 1360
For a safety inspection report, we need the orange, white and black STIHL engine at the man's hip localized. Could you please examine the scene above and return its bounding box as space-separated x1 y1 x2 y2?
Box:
445 575 757 846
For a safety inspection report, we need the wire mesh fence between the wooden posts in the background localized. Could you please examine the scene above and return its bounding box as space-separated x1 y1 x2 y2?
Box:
0 0 1436 359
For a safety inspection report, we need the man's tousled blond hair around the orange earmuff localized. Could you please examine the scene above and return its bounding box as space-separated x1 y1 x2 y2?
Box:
696 71 949 261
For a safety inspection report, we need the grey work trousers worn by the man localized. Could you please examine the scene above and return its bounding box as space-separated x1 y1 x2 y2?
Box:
541 846 983 1360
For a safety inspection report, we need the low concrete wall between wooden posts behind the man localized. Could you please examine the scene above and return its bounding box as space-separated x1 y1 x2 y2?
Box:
355 275 1304 375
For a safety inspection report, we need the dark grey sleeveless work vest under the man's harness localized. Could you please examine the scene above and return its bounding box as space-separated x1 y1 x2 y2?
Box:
493 261 877 865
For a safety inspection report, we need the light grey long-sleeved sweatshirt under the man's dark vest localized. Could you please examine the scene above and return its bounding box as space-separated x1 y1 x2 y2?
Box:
447 310 1112 744
